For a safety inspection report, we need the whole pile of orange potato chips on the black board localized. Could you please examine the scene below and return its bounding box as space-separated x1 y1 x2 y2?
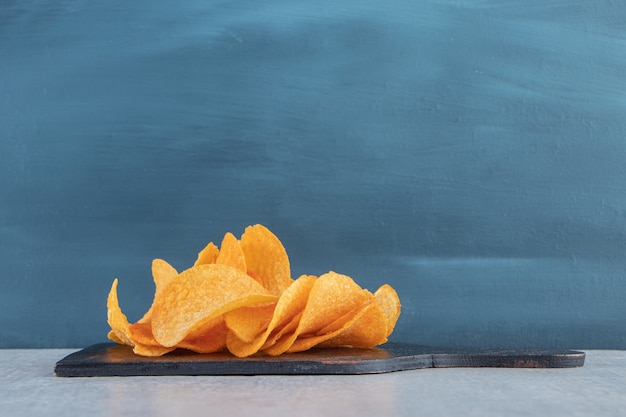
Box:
107 225 400 357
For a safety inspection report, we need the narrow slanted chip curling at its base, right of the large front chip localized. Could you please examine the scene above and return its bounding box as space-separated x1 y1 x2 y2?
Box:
226 275 317 357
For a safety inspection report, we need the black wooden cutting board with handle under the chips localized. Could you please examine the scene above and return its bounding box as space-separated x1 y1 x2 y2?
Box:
54 343 585 377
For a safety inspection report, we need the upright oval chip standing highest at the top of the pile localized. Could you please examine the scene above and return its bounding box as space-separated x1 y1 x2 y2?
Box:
241 224 293 295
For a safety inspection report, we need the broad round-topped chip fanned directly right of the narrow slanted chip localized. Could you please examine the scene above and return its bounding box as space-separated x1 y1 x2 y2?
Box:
264 271 373 356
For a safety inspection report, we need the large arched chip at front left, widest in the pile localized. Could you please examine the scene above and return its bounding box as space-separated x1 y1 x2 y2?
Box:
152 264 278 347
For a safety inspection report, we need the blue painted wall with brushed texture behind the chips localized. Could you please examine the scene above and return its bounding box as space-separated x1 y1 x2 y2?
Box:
0 0 626 348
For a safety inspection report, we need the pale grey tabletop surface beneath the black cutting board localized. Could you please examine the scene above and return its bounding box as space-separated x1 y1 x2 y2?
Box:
0 349 626 417
